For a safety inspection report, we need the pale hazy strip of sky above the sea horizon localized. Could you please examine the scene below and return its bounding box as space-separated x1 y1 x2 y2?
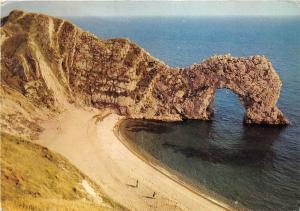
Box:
1 0 300 16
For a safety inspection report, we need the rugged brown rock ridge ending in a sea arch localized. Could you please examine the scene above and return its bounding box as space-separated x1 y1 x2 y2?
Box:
1 11 288 125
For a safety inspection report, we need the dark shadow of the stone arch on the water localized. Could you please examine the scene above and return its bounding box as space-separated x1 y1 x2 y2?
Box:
162 122 284 165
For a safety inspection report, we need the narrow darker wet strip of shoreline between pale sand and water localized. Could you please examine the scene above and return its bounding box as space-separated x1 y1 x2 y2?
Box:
113 119 243 210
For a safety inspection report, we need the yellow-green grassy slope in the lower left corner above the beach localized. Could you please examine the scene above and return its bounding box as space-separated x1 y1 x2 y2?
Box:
1 133 122 210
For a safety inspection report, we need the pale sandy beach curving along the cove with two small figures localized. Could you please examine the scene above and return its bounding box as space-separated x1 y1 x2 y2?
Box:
39 108 231 210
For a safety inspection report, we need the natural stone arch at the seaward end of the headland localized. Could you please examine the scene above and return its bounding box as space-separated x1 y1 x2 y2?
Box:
185 55 288 124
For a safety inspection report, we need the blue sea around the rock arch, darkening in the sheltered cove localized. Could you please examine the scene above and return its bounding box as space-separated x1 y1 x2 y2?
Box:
68 17 300 210
